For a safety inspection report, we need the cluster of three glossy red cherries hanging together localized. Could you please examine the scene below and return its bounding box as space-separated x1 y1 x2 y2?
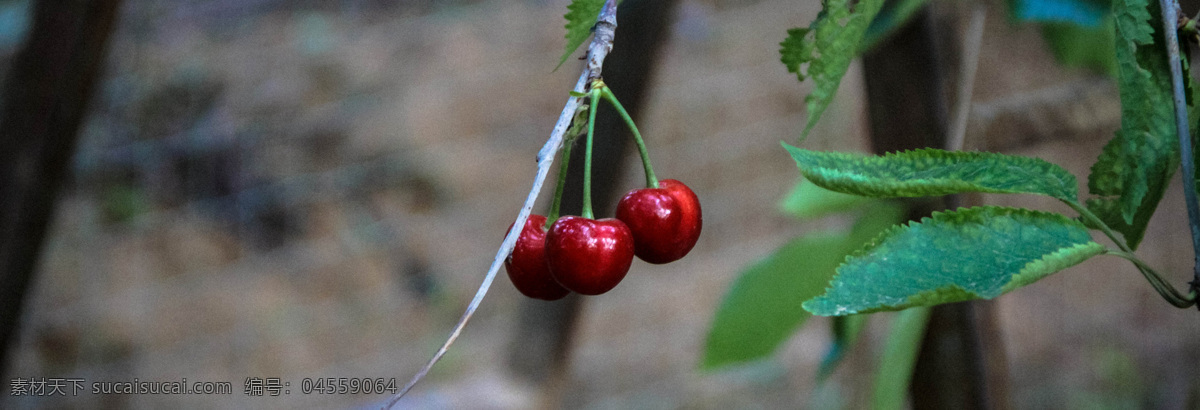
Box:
504 180 702 301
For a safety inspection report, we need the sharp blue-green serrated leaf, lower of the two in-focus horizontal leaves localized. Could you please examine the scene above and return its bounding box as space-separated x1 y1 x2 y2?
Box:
804 206 1104 315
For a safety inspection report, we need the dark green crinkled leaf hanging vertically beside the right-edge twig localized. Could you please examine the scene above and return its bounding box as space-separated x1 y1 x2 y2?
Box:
1087 0 1180 232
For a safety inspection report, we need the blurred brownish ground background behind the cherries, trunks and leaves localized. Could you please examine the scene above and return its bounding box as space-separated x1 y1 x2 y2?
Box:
0 0 1200 409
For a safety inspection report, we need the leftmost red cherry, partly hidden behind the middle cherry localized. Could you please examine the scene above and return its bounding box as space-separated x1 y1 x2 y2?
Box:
504 215 571 301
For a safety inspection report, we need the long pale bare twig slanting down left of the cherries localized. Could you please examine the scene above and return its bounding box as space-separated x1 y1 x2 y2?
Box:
384 0 617 409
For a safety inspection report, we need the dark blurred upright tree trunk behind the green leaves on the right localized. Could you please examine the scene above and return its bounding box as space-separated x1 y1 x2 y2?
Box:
863 6 1008 410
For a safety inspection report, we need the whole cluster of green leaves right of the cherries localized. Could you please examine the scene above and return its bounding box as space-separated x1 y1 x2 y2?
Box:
703 0 1200 383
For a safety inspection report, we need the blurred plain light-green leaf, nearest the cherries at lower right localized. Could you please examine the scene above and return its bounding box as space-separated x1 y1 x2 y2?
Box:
701 235 850 369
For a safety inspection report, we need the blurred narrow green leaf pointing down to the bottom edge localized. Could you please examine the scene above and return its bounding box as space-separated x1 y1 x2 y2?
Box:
871 308 931 410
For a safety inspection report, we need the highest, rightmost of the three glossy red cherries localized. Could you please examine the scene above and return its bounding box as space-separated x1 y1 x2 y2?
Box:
617 180 703 264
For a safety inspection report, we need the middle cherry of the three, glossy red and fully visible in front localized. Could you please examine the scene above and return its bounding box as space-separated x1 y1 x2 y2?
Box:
546 216 634 295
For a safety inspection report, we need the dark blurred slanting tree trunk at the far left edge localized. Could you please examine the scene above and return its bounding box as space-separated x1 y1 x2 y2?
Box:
0 0 120 392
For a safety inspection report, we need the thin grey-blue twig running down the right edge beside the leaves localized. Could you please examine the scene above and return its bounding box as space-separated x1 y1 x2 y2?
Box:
1158 0 1200 306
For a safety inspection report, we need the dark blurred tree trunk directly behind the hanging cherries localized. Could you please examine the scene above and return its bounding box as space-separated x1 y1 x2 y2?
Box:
509 0 677 408
